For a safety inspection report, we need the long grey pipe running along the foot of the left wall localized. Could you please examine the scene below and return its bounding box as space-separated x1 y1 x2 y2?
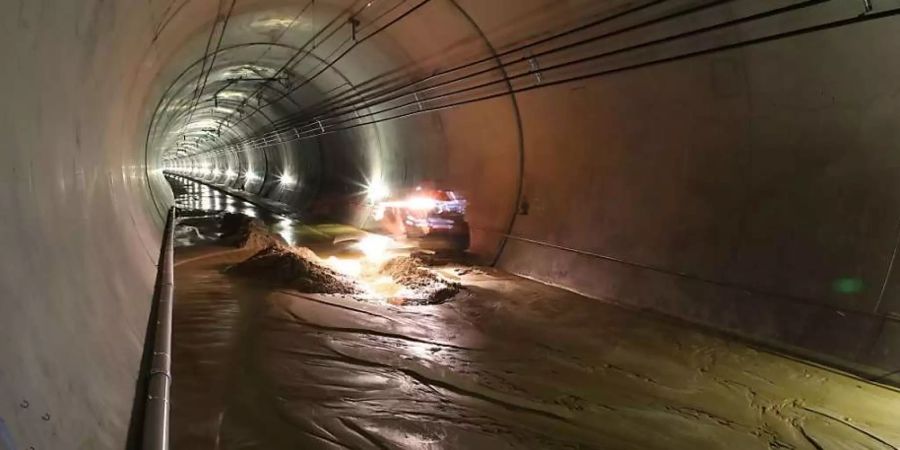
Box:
141 206 175 450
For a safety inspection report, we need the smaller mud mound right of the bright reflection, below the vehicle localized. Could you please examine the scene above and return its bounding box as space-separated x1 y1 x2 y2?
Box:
378 256 462 305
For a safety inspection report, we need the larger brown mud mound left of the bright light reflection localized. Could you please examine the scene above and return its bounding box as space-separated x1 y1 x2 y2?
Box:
226 245 360 294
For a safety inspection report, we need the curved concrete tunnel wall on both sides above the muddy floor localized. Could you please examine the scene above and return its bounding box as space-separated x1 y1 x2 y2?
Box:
0 0 900 449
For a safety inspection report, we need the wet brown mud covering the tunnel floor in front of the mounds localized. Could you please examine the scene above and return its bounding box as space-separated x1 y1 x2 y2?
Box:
172 174 900 450
